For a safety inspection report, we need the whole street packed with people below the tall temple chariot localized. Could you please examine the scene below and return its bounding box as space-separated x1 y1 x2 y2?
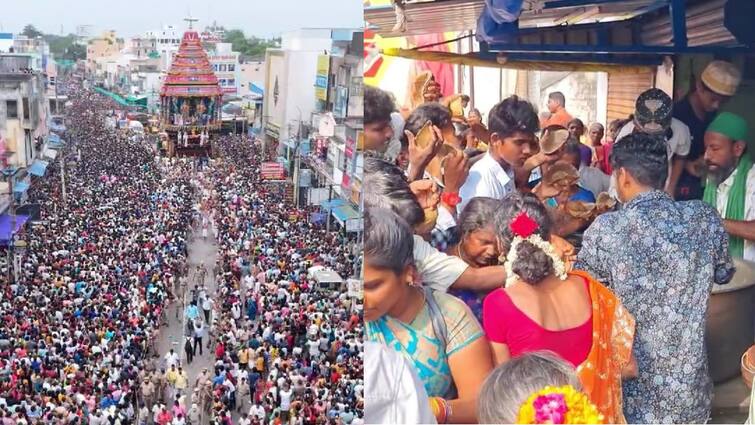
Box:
0 83 363 424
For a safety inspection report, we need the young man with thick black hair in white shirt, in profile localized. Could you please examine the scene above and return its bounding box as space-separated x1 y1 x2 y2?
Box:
457 96 539 213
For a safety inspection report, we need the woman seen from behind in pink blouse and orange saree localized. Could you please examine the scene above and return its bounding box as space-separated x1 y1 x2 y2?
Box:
483 193 637 423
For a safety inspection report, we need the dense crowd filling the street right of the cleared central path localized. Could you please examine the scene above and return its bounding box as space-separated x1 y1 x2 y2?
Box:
176 136 364 424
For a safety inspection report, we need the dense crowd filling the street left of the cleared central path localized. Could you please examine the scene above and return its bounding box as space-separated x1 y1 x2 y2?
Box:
0 82 192 424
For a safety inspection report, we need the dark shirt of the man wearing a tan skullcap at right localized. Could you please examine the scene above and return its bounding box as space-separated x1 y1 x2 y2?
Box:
673 95 715 201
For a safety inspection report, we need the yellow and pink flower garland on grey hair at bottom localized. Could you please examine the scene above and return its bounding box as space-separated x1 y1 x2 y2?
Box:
516 385 605 424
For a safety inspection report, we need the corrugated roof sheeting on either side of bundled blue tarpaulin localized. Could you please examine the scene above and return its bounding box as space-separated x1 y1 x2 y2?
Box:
364 0 659 37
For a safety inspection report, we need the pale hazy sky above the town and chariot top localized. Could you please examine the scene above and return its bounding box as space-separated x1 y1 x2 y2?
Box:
0 0 363 37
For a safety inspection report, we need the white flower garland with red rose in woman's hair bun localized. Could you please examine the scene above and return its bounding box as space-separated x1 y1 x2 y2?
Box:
503 211 566 287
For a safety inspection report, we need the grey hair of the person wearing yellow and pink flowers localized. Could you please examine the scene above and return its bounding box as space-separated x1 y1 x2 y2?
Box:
477 351 582 424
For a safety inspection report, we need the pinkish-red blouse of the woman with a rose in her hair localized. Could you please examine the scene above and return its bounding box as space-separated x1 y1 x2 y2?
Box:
482 281 592 367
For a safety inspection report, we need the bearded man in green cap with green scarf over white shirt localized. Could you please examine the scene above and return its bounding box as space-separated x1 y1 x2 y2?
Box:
703 112 755 261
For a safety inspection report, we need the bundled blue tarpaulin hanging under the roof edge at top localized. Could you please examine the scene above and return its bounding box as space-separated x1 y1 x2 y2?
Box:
477 0 524 43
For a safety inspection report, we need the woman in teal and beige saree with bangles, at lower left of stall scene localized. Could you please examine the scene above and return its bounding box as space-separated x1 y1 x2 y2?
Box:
364 209 493 423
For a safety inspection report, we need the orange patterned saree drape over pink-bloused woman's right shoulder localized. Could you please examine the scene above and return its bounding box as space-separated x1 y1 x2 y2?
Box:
569 271 635 424
